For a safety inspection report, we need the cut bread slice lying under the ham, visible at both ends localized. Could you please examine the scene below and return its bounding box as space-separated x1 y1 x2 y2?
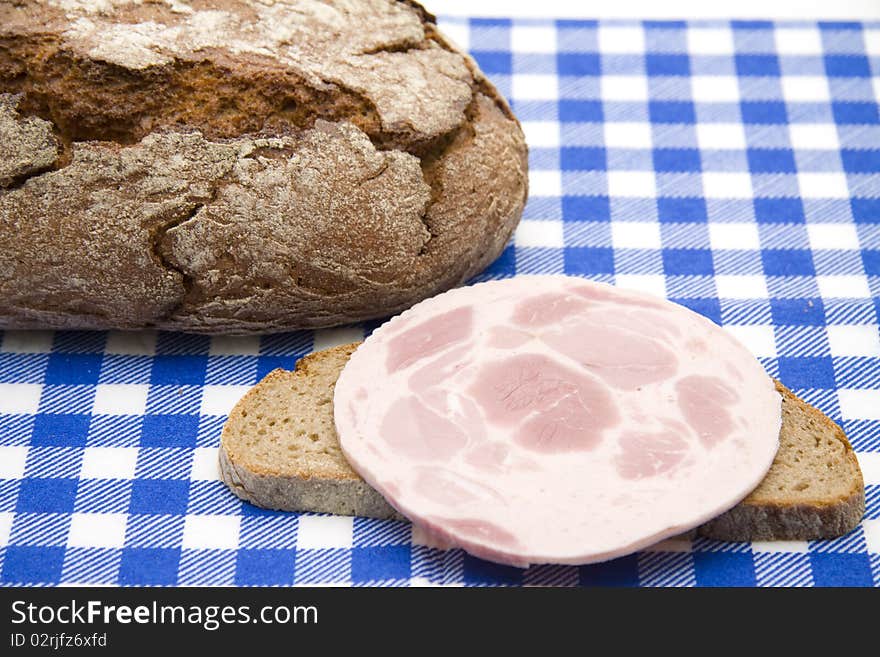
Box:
220 343 865 541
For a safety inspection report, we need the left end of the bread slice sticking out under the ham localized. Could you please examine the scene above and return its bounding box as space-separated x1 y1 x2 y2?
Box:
220 343 401 518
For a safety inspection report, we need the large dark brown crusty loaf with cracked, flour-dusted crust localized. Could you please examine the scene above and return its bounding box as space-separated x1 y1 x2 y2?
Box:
0 0 527 333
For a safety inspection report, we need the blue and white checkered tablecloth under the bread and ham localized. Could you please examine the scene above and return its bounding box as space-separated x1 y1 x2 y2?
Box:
0 20 880 586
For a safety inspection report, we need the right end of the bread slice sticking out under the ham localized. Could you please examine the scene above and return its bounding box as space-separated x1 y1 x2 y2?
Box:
699 381 865 541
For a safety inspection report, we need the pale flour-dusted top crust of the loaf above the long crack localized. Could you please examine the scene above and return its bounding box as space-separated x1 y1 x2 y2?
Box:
45 0 473 136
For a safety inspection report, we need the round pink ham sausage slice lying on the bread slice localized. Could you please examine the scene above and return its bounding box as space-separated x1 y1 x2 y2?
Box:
335 276 781 566
